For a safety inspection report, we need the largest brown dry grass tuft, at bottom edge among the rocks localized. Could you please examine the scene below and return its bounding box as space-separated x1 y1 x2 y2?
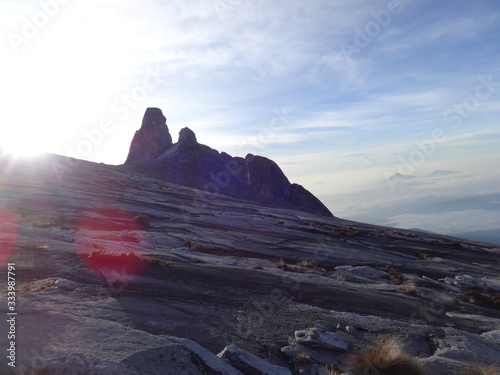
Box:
347 338 426 375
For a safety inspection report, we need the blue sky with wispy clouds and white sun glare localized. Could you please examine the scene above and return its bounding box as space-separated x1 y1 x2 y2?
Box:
0 0 500 241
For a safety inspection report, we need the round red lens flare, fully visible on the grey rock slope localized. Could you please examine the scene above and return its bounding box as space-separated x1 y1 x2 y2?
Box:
76 206 144 285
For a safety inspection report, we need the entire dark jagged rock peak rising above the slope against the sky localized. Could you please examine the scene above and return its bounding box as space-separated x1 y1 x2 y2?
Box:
125 108 333 216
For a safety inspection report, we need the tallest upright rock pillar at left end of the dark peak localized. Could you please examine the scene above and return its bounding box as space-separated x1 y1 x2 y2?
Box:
125 108 172 164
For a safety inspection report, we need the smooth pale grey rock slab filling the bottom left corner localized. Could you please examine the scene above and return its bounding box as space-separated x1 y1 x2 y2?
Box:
0 310 243 375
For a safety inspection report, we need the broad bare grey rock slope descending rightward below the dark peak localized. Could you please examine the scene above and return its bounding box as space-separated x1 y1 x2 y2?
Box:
0 153 500 375
